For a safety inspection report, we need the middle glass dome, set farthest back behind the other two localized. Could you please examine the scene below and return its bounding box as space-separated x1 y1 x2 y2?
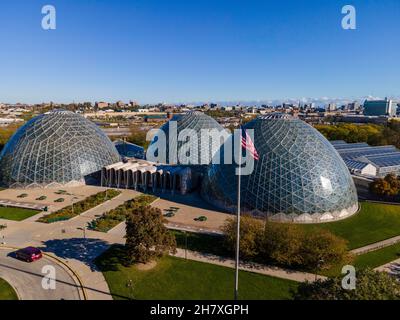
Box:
150 111 225 165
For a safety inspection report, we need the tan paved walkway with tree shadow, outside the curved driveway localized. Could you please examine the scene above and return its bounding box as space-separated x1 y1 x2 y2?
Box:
0 190 139 300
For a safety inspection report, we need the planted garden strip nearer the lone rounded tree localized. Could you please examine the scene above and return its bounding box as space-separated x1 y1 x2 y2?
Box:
88 195 157 232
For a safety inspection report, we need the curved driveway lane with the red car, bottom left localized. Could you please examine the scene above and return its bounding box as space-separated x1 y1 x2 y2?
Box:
0 248 80 300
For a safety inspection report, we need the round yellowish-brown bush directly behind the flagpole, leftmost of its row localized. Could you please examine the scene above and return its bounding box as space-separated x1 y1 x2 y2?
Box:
222 215 263 259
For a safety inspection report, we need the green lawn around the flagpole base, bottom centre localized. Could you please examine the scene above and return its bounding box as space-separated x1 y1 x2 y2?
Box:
96 247 297 300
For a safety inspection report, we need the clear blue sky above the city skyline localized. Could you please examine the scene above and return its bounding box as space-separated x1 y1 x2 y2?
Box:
0 0 400 103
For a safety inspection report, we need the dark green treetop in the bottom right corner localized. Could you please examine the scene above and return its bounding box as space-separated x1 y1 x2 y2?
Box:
293 269 400 300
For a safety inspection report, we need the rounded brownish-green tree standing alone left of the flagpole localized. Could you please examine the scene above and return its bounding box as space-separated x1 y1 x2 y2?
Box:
125 206 176 264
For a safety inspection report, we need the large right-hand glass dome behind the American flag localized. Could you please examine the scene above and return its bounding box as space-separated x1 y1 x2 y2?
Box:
202 114 358 223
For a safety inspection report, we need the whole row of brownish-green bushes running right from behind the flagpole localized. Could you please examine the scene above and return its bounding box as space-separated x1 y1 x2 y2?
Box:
222 216 350 271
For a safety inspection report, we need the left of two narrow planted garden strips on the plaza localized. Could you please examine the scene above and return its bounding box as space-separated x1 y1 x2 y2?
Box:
38 189 121 223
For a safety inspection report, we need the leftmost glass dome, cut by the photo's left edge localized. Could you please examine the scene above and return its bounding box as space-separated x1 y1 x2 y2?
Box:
0 111 119 187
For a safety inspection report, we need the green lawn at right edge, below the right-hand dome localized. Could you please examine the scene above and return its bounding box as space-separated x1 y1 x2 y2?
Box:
302 202 400 249
